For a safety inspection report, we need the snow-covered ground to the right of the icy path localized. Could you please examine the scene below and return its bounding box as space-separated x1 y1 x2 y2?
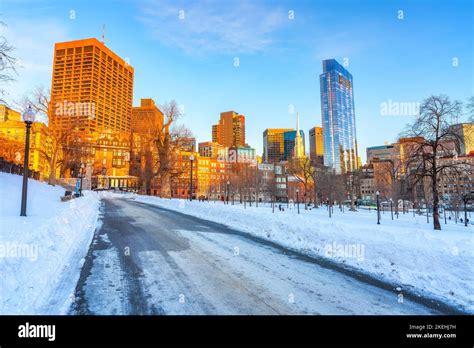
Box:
136 196 474 313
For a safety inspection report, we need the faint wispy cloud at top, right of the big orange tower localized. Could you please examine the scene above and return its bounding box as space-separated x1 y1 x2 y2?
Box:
139 0 288 54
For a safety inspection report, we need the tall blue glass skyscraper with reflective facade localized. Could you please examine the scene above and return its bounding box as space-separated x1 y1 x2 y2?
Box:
319 59 359 173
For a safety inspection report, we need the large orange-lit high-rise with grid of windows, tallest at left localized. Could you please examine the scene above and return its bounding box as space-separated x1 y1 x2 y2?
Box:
49 38 134 132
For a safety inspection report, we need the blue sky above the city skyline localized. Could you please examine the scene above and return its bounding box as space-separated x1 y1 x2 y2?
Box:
0 0 474 160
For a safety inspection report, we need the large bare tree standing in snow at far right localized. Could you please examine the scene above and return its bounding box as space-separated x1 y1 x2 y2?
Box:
403 95 461 230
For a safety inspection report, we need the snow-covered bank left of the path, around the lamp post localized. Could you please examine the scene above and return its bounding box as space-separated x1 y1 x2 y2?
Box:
0 173 99 314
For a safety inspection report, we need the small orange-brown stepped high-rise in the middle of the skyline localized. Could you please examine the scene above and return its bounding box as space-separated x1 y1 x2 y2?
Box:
212 111 246 147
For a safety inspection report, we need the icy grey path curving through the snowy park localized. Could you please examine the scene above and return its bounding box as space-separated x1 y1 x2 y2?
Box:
71 199 436 314
